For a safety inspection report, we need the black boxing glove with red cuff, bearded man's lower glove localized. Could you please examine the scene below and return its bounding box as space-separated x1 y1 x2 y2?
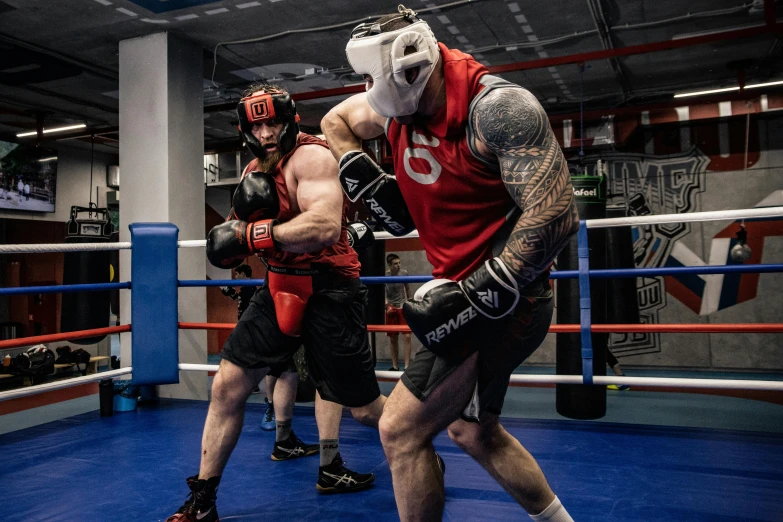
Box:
207 219 277 268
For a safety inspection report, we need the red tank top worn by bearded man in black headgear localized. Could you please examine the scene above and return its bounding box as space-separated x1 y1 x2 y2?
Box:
242 132 361 279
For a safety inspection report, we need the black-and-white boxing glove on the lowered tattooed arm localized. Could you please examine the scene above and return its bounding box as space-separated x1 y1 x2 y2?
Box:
402 258 519 358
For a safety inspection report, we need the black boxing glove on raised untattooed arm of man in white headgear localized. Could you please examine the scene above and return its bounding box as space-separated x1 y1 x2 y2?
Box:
340 150 416 236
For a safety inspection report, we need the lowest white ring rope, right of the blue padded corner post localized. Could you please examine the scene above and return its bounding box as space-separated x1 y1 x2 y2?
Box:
179 364 783 391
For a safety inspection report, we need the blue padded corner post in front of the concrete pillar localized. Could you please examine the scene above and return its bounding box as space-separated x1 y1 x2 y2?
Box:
129 223 179 384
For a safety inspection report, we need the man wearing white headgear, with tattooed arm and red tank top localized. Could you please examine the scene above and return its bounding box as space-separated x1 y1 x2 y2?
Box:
321 6 579 522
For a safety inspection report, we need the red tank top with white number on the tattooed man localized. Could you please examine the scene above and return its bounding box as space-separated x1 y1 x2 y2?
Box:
386 43 514 281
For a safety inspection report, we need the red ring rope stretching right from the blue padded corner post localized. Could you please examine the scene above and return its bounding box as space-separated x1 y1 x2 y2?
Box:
179 323 783 333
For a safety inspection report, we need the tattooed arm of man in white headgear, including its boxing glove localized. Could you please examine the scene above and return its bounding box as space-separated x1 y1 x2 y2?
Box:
403 88 579 357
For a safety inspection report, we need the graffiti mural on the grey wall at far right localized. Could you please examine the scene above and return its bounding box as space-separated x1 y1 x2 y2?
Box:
586 147 783 355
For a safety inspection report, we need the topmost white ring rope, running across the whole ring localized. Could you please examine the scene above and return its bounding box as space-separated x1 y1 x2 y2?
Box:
0 207 783 254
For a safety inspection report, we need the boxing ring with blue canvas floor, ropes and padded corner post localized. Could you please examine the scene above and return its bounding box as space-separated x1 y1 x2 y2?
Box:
0 207 783 521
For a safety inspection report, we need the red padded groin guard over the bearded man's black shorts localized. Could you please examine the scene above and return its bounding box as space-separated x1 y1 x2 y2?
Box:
266 263 313 337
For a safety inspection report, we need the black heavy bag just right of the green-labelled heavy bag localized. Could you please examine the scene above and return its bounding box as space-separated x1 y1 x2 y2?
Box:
606 206 639 324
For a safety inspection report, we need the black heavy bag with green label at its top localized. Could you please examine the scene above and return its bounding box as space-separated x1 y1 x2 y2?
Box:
556 176 609 419
